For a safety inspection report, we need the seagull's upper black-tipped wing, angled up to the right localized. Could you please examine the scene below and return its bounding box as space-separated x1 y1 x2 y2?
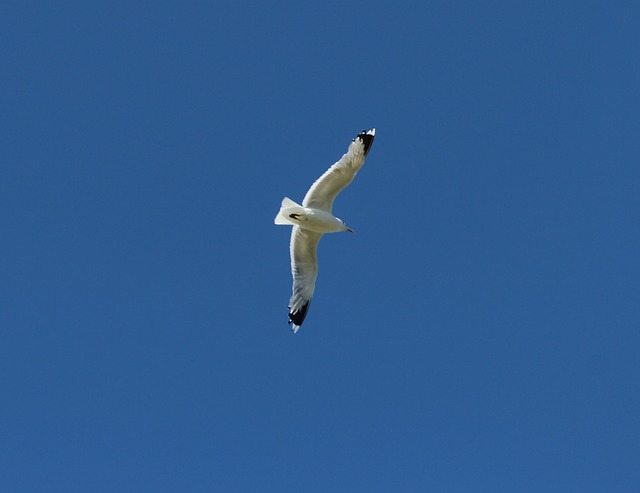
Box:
302 128 376 212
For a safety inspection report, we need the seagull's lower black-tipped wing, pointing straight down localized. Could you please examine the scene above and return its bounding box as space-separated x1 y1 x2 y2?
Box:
289 226 322 334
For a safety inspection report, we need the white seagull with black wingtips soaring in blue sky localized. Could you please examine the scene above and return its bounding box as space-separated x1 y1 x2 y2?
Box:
274 128 376 334
